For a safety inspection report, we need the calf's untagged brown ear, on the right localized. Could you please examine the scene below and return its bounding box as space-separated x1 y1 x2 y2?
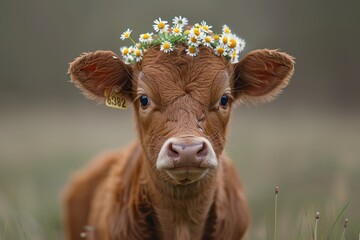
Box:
233 49 295 104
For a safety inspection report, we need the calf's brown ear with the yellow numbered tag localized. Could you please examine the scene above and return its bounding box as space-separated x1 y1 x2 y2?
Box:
68 51 132 102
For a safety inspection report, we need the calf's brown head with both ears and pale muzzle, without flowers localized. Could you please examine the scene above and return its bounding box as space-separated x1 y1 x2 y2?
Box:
69 46 294 185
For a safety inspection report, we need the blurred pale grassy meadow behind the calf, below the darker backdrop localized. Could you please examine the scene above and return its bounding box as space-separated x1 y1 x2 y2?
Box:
0 100 360 240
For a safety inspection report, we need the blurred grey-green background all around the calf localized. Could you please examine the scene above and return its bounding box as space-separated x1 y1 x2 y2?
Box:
0 0 360 239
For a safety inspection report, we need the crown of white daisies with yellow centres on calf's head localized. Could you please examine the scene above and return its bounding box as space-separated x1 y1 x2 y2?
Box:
120 16 245 64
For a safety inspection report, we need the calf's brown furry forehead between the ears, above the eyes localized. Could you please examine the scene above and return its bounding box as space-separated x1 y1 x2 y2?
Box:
136 48 230 104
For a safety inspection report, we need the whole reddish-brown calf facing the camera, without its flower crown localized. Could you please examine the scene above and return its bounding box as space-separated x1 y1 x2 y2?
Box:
65 46 294 240
